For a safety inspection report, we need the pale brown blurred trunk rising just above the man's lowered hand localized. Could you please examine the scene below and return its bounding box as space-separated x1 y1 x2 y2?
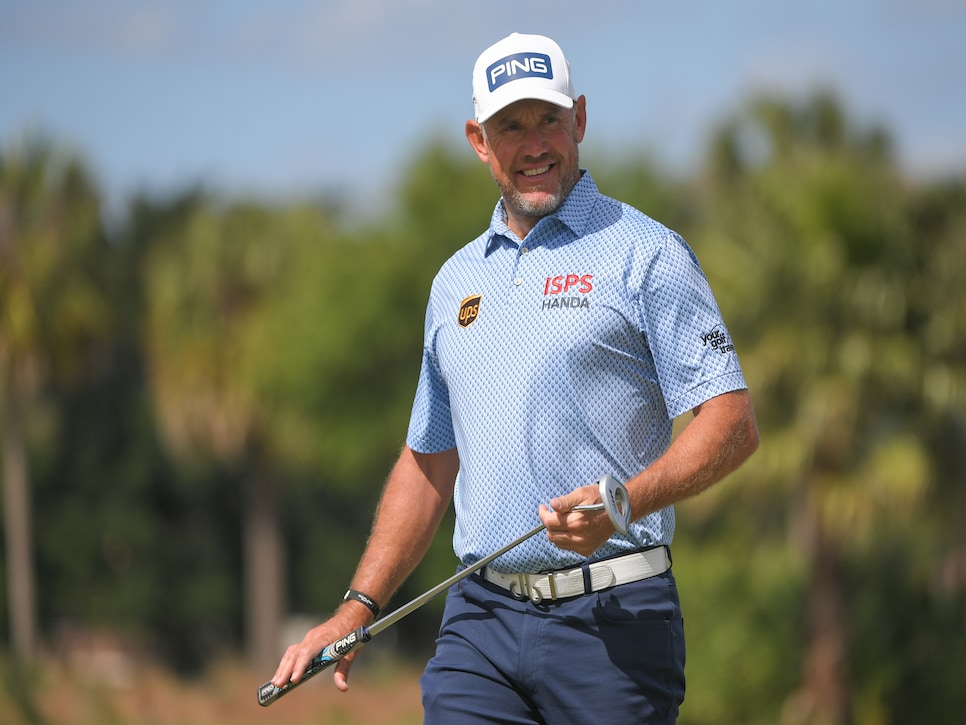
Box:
242 465 285 670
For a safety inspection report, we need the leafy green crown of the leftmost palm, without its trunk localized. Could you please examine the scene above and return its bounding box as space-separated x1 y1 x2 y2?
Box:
0 137 112 385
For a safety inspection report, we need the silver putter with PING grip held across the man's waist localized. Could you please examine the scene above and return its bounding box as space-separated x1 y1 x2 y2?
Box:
258 475 631 707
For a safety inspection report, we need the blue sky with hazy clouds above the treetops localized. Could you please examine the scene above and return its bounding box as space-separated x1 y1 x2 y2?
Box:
0 0 966 212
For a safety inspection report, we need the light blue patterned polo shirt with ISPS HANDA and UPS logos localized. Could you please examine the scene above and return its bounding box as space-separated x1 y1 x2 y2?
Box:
407 172 746 572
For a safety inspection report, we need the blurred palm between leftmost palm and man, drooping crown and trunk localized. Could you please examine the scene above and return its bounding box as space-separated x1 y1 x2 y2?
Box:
144 198 312 668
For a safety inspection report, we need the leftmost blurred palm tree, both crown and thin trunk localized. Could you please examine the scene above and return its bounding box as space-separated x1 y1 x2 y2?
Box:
0 138 112 658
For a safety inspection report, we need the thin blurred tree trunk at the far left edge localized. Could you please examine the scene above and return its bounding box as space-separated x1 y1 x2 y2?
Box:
0 379 37 659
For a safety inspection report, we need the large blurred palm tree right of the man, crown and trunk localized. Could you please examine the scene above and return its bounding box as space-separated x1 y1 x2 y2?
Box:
702 93 930 725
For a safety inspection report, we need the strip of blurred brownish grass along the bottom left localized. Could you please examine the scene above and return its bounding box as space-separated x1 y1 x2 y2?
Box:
0 660 422 725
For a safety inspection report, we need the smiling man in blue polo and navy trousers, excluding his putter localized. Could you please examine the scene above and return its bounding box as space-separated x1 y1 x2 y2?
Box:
273 34 758 725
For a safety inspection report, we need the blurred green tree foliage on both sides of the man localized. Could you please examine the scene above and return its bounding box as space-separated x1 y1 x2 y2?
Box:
0 93 966 724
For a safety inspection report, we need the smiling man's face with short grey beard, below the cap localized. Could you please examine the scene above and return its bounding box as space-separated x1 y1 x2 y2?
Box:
466 96 587 238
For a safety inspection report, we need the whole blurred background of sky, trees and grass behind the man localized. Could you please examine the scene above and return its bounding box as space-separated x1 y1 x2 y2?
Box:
0 0 966 725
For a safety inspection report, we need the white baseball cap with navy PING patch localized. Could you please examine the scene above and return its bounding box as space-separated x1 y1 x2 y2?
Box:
473 33 577 123
